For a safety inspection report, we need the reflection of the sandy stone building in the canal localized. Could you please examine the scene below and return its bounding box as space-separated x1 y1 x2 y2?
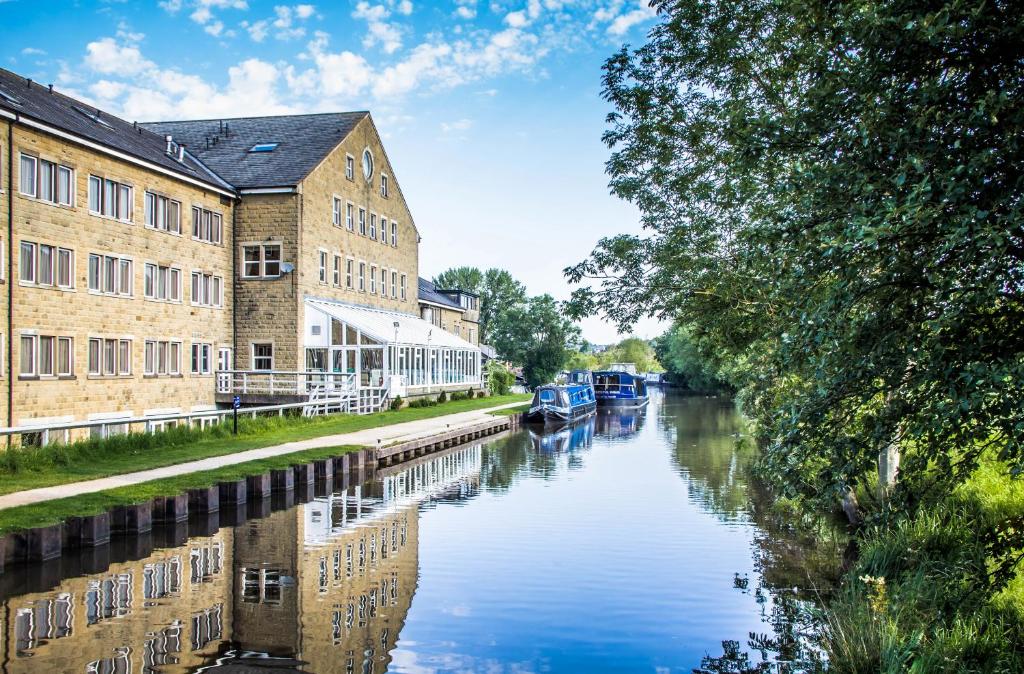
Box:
0 446 481 674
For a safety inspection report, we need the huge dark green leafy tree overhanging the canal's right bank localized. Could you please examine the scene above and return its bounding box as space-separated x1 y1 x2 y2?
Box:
566 0 1024 531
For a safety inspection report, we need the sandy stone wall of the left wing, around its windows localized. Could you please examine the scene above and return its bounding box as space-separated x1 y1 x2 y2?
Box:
3 126 233 424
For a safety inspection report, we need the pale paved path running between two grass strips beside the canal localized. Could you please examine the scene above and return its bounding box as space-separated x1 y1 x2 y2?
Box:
0 403 522 510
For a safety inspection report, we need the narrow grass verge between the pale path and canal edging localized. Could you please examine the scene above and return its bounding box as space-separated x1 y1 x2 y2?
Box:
0 446 361 535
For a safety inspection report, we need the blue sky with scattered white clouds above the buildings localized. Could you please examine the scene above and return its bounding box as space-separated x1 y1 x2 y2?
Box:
0 0 663 343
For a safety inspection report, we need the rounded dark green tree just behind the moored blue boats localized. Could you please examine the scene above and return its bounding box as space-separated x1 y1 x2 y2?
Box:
490 295 580 386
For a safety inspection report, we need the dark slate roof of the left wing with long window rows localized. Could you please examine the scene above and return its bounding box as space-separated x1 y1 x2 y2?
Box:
0 69 230 189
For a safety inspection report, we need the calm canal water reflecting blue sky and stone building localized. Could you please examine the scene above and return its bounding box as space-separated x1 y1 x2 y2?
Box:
0 391 823 674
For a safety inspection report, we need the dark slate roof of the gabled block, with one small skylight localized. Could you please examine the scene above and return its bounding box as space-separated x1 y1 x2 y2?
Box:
141 111 370 189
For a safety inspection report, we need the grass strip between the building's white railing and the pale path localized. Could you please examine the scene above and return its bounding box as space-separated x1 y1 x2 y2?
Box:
0 395 529 495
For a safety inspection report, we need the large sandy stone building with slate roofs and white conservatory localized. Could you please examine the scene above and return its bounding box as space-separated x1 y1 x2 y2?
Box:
0 65 479 433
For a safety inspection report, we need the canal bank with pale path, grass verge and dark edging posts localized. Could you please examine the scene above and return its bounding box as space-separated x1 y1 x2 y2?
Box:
0 401 519 570
